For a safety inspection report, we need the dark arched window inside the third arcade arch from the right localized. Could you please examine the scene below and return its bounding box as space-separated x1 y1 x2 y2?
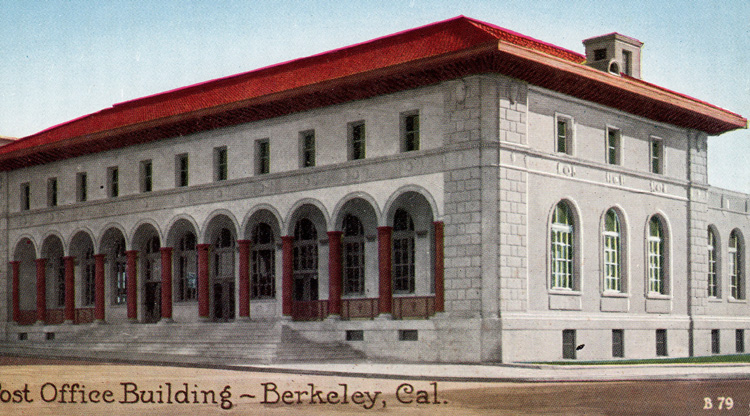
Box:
293 218 318 301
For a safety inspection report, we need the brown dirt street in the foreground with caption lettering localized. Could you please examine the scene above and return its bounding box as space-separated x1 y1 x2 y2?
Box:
0 357 750 416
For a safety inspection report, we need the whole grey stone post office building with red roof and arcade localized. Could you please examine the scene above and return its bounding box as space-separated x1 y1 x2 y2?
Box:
0 17 750 362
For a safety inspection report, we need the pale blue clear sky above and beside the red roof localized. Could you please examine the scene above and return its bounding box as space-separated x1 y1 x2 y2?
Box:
0 0 750 193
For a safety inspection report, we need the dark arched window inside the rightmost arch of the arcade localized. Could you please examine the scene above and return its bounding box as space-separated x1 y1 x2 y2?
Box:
393 208 416 293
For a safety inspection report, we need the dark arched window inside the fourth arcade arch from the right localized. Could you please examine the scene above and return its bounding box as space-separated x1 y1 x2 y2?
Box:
250 222 276 299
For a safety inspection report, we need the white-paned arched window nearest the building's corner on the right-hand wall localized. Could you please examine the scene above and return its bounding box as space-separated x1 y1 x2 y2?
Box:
550 202 574 289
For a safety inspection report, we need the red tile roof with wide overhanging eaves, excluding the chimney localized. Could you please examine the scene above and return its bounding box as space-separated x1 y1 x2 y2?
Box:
0 16 747 170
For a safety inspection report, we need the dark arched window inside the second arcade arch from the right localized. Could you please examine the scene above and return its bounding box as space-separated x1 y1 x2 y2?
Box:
341 214 365 295
